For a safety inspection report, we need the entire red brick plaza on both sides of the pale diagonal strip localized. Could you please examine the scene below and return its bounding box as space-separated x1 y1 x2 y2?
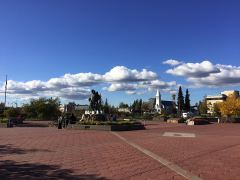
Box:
0 122 240 180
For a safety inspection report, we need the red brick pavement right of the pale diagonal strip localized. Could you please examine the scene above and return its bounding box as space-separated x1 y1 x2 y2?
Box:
119 123 240 180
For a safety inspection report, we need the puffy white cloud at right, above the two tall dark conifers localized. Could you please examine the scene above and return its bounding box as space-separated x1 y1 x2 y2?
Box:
166 61 240 87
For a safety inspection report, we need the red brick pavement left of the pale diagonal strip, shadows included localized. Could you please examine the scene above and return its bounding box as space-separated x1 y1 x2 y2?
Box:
0 128 183 179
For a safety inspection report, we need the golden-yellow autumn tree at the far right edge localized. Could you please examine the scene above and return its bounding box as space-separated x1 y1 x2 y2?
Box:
218 95 240 117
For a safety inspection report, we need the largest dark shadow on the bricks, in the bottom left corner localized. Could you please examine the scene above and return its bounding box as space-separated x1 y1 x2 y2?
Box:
0 160 106 180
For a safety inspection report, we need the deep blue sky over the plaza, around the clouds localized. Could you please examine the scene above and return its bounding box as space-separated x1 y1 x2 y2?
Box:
0 0 240 105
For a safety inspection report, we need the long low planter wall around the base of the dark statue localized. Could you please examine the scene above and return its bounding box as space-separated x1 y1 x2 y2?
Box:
68 124 145 131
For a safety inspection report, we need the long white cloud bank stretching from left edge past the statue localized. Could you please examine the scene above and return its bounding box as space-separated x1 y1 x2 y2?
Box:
0 66 174 100
